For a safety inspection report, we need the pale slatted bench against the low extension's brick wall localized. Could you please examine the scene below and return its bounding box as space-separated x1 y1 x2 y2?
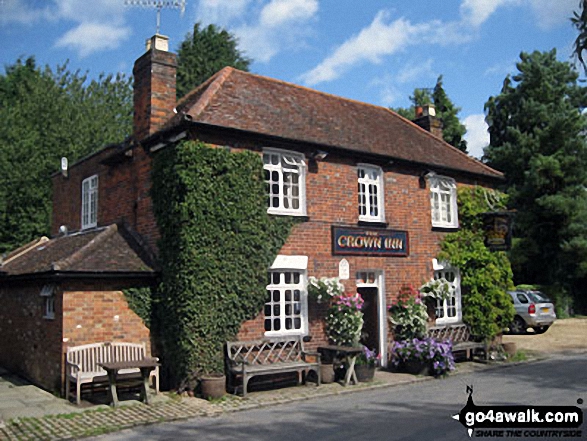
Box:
65 342 159 405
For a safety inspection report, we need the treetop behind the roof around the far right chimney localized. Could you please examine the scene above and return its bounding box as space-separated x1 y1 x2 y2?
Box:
392 75 467 153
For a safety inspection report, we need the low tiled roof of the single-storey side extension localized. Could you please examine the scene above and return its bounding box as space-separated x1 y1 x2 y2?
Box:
0 225 155 276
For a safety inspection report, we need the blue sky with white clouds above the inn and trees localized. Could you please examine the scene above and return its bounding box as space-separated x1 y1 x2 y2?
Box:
0 0 579 157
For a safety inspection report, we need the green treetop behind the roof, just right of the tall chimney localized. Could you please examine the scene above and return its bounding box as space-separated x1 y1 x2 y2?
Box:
177 23 251 98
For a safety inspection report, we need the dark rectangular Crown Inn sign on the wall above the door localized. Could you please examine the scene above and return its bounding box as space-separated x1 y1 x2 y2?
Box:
332 227 409 257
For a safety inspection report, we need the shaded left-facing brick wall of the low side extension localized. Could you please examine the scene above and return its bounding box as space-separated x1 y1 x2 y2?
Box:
0 283 62 391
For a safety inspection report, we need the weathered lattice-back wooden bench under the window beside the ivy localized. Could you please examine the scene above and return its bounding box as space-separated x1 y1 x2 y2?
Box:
226 337 321 397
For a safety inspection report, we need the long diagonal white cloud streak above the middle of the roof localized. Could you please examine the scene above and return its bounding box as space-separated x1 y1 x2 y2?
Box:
301 11 428 85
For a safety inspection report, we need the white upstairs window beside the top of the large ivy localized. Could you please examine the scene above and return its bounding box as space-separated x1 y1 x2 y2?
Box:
263 148 306 216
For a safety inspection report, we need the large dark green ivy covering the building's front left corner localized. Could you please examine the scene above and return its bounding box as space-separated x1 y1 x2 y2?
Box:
152 141 294 388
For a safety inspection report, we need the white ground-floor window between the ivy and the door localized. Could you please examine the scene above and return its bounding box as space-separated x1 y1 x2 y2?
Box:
263 256 308 337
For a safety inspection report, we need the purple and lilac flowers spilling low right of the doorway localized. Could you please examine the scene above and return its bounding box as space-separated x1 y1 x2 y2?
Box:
391 337 455 377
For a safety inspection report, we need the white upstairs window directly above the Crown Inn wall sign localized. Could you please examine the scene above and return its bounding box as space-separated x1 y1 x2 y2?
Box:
357 164 385 222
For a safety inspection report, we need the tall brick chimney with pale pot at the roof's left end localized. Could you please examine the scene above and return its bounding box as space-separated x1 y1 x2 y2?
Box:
132 34 177 141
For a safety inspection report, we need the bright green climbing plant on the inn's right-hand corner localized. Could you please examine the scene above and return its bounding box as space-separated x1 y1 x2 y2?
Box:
439 187 514 340
